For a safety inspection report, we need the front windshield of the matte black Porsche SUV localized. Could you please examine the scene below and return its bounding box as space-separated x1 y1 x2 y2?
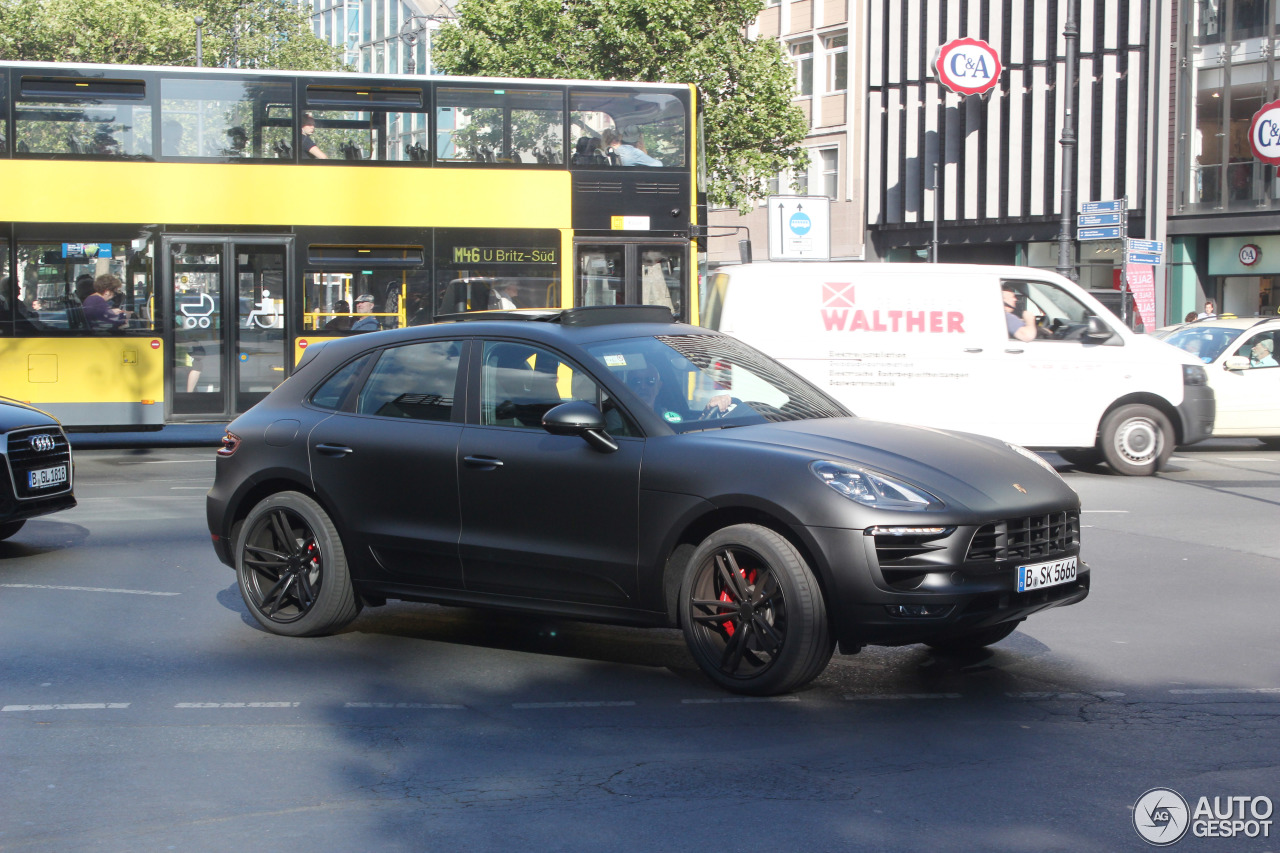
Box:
586 334 850 432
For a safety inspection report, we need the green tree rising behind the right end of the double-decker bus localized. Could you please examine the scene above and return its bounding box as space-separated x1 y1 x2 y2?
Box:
433 0 808 209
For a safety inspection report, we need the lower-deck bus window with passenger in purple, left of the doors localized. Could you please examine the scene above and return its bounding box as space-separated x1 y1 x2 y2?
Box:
14 237 155 336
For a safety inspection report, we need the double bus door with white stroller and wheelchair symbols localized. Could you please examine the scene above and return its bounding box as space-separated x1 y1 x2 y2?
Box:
163 234 292 421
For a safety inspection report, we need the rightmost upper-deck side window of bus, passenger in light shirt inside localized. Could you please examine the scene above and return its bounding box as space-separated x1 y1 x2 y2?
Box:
568 92 687 168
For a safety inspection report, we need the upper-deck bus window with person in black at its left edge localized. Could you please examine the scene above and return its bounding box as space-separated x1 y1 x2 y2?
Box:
306 86 428 164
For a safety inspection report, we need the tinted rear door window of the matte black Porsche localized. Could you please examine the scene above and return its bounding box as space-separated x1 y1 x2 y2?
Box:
356 341 462 420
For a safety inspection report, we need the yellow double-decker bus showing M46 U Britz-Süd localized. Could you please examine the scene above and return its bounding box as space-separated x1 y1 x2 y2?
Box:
0 63 705 429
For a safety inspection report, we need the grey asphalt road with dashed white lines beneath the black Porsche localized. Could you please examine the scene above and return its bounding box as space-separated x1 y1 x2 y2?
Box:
0 441 1280 853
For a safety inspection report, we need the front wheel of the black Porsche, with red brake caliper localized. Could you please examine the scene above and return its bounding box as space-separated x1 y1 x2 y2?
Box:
680 524 835 695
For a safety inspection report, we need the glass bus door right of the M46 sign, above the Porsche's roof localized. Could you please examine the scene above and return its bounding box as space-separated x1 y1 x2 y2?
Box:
573 240 689 320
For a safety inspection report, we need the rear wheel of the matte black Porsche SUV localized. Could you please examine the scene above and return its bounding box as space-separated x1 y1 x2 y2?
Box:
236 492 361 637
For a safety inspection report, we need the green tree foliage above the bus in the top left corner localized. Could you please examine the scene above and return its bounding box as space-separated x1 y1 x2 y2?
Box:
0 0 342 70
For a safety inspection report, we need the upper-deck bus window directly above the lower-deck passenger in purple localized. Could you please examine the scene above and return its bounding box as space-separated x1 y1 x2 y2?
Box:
14 77 152 158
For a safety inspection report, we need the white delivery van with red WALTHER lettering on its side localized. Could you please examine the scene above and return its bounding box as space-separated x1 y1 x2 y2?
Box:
703 263 1213 475
